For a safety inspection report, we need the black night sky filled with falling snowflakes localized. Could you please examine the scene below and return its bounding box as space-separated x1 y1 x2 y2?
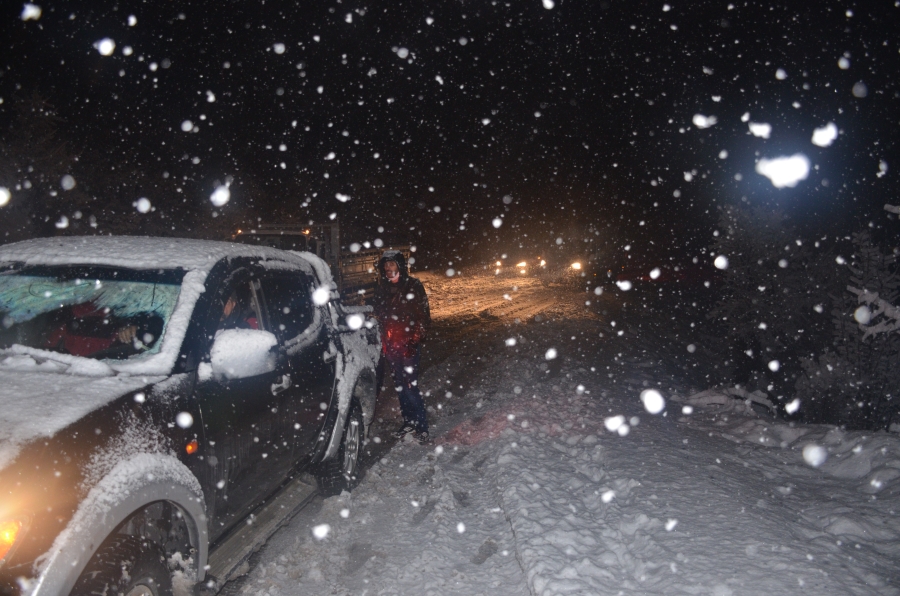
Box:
0 0 900 266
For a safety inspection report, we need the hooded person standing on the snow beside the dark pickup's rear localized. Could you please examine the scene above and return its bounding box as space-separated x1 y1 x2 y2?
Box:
372 250 431 444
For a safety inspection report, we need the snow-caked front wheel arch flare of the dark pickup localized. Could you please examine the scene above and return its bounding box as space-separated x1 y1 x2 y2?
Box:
30 453 209 596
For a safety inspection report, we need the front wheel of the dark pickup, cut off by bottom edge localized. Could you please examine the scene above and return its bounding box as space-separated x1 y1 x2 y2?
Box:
72 534 172 596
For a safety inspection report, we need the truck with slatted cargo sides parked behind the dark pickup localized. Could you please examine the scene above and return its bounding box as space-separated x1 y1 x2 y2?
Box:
231 221 410 301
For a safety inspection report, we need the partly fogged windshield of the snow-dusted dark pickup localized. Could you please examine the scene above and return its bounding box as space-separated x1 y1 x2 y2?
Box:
0 268 184 360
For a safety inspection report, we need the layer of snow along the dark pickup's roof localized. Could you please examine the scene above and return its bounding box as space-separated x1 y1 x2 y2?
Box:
0 236 331 283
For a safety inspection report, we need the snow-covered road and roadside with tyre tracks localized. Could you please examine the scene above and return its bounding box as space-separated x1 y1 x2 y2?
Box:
225 275 900 596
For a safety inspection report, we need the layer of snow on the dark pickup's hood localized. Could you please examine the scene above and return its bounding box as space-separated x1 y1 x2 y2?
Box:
0 369 164 470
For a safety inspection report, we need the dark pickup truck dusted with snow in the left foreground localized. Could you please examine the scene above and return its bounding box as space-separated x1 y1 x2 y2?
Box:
0 236 381 596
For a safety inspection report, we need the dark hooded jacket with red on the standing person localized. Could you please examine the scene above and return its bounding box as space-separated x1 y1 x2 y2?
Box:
372 250 431 355
